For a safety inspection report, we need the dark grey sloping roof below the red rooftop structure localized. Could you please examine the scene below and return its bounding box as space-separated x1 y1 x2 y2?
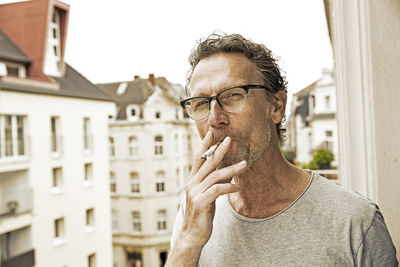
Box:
0 64 113 101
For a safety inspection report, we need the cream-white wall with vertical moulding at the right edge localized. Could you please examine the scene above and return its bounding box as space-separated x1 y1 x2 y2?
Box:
329 0 400 258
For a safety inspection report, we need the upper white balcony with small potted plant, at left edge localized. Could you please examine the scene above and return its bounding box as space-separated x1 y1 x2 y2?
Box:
0 171 32 234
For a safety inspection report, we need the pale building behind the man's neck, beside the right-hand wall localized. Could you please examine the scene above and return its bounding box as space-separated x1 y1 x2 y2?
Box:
285 69 339 166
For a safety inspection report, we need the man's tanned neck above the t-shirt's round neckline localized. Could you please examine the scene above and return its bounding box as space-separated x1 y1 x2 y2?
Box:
230 145 311 218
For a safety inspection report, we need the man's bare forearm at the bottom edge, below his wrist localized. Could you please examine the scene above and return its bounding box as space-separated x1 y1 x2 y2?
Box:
165 239 202 267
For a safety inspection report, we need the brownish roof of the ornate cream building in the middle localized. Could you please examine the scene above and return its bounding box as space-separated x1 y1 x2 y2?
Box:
97 75 183 120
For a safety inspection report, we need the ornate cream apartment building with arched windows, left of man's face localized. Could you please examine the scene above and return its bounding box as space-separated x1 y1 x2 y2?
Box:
99 74 199 267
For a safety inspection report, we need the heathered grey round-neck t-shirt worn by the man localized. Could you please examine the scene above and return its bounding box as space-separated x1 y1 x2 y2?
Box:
171 173 398 267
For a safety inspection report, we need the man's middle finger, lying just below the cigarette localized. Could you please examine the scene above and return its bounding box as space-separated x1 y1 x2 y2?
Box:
193 136 231 183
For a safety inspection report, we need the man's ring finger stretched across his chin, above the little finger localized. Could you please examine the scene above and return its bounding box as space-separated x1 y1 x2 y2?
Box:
196 160 247 193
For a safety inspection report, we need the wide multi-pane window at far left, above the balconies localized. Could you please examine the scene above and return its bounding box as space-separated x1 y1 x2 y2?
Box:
0 115 25 158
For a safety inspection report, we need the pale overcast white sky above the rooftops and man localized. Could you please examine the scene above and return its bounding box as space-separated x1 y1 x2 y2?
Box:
0 0 333 110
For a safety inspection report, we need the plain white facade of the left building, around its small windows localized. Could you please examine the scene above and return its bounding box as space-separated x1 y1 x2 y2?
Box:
0 91 114 266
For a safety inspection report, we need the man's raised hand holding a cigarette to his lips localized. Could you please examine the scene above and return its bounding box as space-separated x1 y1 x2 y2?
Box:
171 131 247 257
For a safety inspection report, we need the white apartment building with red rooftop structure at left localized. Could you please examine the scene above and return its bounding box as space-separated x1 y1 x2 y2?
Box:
0 0 115 267
